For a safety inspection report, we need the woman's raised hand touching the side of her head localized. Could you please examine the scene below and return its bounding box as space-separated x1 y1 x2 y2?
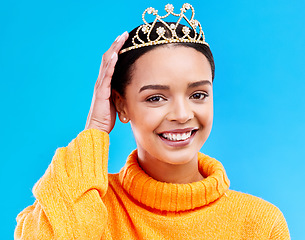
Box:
85 32 128 133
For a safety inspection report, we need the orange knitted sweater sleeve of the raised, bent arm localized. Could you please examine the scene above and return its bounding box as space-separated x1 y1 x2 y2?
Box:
15 129 109 240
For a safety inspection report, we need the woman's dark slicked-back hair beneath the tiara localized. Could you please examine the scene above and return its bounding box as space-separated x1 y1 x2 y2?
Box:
111 22 215 97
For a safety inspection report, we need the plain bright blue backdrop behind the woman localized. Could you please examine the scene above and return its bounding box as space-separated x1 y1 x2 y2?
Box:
0 0 305 239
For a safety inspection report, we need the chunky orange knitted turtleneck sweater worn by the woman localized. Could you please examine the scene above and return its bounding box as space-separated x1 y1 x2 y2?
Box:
15 129 290 240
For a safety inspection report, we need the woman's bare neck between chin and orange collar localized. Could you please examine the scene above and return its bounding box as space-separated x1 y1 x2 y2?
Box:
138 153 204 184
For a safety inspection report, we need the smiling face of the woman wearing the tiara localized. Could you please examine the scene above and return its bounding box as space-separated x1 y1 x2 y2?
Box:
117 45 213 167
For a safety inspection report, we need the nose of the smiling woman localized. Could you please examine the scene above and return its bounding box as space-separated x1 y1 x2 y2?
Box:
167 98 194 123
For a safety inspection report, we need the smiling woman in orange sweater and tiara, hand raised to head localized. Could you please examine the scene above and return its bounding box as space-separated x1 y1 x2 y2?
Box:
15 4 289 239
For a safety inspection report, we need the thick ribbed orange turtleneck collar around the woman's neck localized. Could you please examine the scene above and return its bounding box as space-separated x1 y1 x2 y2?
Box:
119 150 230 212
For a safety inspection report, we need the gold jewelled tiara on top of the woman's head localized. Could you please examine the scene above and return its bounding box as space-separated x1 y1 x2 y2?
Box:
120 3 208 54
